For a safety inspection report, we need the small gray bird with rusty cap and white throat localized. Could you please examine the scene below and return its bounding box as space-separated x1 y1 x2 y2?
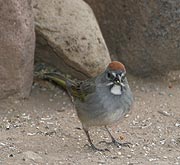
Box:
43 61 134 151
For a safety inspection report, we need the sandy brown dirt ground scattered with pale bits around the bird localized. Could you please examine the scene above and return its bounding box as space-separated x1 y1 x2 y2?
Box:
0 72 180 165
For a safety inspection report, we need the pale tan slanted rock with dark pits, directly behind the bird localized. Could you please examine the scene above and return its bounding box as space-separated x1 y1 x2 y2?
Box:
33 0 110 78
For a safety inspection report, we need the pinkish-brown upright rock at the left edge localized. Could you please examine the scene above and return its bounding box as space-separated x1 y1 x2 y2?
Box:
0 0 35 98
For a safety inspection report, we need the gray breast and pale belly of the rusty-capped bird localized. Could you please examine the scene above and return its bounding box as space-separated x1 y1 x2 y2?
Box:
76 82 133 127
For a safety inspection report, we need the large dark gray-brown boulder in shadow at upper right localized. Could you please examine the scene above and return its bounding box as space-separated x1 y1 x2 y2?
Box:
85 0 180 76
